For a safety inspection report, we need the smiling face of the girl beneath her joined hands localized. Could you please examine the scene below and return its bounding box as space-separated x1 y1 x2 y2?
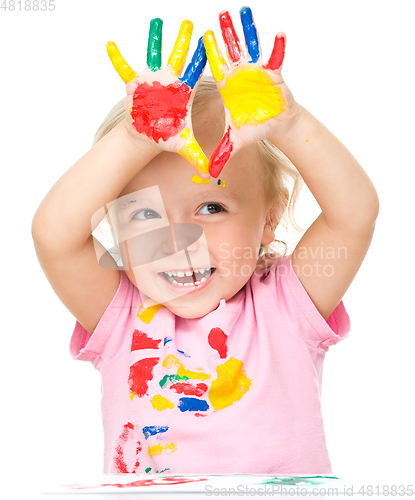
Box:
117 124 274 318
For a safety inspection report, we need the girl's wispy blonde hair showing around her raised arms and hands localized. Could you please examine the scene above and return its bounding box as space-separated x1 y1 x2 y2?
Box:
93 76 304 271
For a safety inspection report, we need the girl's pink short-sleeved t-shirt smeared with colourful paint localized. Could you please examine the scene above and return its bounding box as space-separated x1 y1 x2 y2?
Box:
70 255 350 475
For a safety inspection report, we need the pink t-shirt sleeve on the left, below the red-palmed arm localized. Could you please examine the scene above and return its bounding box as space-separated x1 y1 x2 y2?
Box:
69 271 134 369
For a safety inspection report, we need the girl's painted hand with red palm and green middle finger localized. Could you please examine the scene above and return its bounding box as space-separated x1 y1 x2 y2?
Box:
107 19 210 179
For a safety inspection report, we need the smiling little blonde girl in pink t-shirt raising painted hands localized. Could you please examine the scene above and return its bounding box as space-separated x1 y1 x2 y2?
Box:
33 8 378 475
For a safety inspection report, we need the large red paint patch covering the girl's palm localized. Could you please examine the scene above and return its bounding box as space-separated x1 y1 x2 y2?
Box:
131 82 191 142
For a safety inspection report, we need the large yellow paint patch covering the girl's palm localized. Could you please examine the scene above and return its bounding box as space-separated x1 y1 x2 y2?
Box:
220 66 285 129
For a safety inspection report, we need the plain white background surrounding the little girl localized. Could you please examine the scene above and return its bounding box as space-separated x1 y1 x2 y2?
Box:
0 0 415 498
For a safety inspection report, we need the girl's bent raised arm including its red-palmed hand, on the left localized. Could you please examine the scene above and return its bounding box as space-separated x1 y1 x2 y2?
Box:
32 19 209 333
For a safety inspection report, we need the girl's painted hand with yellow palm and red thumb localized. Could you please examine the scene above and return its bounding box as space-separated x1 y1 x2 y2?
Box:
204 7 298 177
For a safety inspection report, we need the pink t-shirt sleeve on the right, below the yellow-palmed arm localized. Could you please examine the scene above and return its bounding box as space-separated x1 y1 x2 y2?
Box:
266 254 350 351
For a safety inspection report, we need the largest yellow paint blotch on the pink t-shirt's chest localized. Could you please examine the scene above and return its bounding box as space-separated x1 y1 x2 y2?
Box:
208 358 252 410
